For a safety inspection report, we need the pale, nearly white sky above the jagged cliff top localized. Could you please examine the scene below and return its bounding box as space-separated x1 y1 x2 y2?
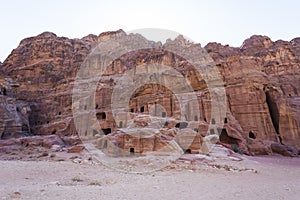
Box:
0 0 300 62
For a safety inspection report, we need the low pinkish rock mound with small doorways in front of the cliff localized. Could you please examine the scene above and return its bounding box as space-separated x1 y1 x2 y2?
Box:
95 114 213 156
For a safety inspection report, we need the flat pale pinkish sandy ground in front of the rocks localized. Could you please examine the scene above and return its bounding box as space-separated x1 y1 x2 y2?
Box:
0 152 300 200
